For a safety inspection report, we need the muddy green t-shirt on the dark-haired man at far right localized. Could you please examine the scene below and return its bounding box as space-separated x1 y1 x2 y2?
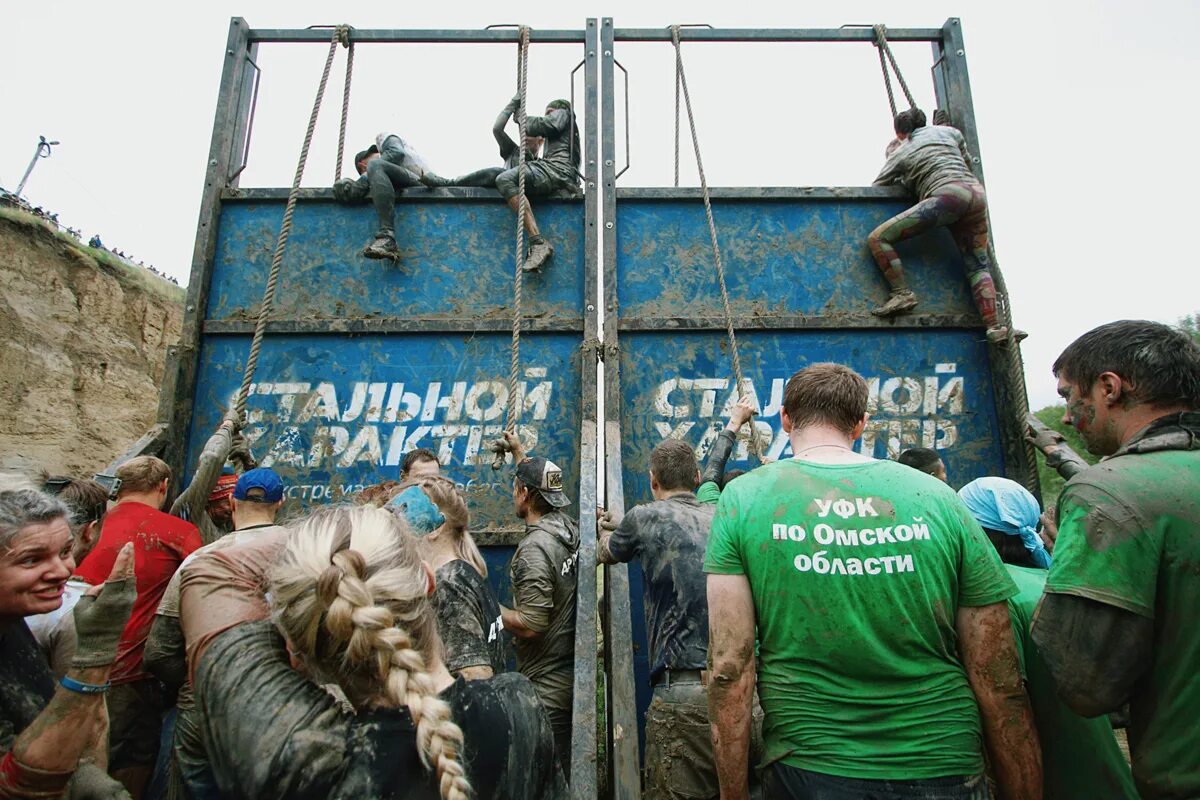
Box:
1046 450 1200 798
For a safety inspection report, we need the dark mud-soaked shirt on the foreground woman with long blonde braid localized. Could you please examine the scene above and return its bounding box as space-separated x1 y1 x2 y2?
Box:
196 620 566 800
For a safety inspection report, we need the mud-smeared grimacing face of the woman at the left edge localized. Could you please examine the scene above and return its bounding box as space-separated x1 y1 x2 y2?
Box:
0 517 74 619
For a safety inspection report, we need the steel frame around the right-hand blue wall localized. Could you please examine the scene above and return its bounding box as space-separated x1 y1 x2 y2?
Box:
600 17 1037 800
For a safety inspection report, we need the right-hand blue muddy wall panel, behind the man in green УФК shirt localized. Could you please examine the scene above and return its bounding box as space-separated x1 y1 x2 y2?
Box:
616 190 1004 753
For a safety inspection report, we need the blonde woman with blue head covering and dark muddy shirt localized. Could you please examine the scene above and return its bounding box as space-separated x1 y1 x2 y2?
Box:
386 476 510 680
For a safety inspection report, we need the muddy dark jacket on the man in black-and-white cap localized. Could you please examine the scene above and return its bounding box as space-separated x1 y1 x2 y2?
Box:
509 511 580 711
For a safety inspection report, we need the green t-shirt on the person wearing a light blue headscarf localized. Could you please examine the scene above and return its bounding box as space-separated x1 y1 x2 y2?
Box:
1004 564 1138 800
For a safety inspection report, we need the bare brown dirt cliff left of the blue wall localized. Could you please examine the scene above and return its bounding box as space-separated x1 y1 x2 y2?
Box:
0 209 184 476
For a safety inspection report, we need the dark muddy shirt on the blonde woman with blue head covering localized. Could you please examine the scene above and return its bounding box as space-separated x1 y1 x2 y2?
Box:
433 559 509 675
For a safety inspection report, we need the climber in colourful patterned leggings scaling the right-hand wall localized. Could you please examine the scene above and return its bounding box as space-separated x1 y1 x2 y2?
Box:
866 108 1025 343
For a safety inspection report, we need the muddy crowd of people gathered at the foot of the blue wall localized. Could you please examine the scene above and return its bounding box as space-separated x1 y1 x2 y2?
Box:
0 320 1200 800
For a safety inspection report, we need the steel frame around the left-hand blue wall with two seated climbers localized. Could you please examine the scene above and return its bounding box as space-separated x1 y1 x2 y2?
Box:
169 17 600 800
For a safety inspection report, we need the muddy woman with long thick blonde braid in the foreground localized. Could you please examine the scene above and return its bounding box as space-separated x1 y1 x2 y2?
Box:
181 506 565 800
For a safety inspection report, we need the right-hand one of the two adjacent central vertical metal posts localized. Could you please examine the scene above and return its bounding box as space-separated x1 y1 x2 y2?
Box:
600 17 643 800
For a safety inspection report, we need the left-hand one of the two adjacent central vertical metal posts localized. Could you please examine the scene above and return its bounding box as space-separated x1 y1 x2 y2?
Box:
571 17 600 800
